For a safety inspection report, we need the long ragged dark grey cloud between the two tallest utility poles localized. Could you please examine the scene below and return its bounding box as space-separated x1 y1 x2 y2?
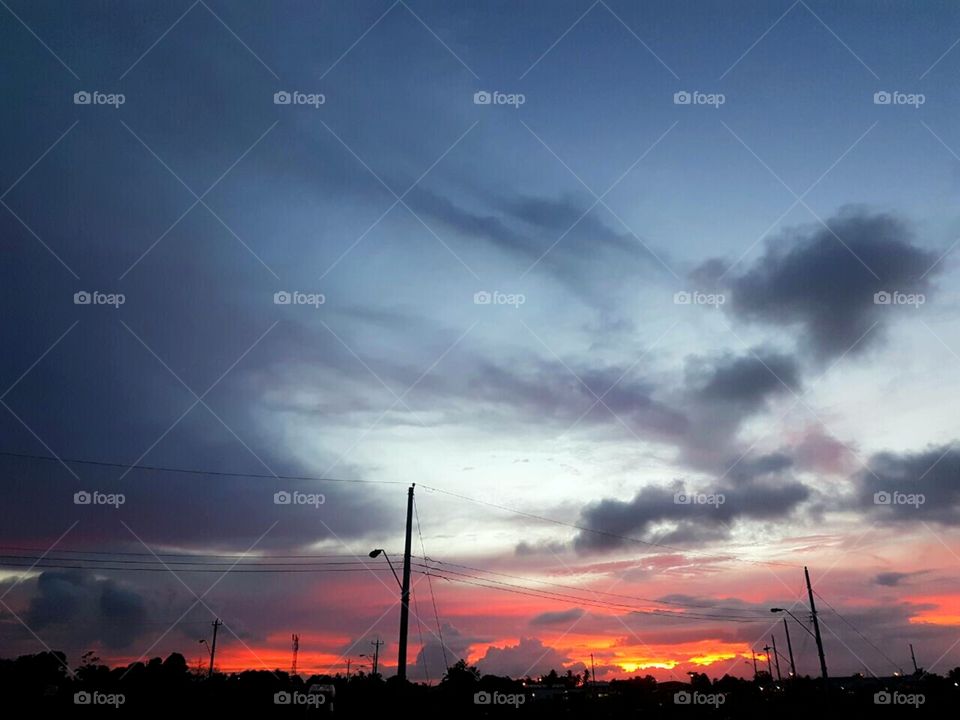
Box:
574 477 811 551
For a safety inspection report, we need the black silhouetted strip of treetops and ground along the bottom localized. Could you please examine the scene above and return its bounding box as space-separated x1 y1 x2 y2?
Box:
0 652 960 720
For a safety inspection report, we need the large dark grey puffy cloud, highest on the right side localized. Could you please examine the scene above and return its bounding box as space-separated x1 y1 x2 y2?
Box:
699 209 942 360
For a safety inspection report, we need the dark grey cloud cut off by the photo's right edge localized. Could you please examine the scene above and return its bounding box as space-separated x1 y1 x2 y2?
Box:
854 444 960 525
